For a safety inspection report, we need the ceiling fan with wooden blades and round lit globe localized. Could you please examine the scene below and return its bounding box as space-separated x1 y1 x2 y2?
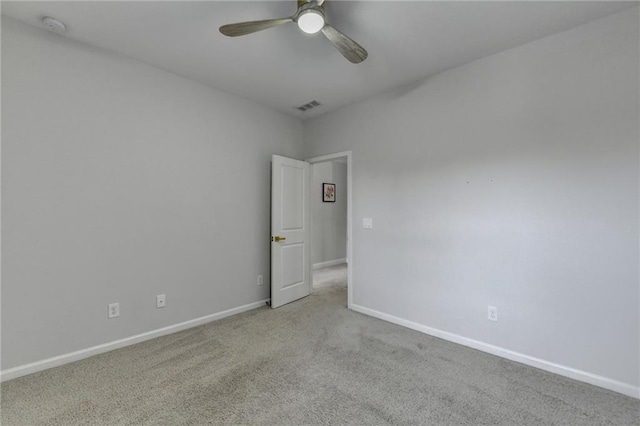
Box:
220 0 368 64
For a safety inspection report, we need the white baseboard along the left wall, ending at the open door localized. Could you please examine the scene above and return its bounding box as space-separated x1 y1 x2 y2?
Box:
0 299 270 382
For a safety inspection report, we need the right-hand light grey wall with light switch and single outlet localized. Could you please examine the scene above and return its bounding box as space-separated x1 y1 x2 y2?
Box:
305 8 640 393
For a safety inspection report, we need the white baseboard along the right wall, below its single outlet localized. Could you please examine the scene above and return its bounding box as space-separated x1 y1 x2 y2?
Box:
349 304 640 399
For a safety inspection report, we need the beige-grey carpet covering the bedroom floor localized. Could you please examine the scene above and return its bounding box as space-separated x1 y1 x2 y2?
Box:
1 278 640 426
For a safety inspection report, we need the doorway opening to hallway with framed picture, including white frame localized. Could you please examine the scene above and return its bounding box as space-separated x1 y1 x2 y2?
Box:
307 151 353 307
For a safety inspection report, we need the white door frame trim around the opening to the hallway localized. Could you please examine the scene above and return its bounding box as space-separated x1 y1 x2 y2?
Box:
305 151 353 309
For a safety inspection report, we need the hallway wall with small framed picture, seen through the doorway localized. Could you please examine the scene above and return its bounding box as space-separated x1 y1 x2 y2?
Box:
311 161 347 266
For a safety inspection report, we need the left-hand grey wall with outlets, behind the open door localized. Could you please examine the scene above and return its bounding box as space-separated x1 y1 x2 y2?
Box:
2 18 302 369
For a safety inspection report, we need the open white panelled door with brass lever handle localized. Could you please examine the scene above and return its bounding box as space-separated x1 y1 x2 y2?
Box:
271 155 311 308
